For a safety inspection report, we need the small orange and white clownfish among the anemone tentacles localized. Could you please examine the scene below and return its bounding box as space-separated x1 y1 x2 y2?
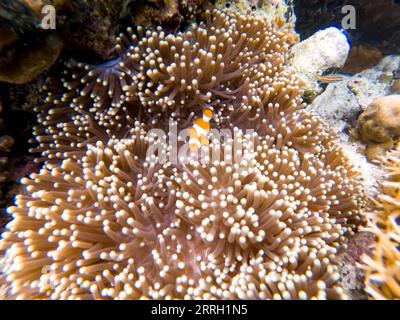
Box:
189 108 213 152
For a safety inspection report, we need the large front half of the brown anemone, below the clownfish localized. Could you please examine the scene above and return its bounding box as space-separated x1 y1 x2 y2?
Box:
1 125 361 299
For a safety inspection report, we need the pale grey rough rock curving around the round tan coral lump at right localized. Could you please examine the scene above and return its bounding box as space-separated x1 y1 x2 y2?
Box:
307 55 400 193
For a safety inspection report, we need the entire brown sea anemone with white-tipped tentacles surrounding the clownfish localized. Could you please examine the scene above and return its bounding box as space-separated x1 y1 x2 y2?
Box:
0 11 364 299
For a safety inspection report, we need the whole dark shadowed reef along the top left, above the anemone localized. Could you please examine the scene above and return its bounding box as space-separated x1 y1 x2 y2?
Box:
0 0 209 84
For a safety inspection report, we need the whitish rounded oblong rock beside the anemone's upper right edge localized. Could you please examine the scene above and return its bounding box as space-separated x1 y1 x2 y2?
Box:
289 27 350 92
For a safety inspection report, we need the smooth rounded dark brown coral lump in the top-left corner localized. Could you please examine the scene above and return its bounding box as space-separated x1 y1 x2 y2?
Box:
0 0 70 84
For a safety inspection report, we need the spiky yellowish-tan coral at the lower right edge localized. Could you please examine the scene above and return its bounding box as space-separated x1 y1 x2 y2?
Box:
363 147 400 300
